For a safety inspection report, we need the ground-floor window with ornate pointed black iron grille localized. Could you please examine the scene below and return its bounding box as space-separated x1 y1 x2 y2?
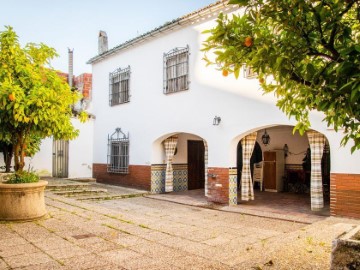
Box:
107 128 130 174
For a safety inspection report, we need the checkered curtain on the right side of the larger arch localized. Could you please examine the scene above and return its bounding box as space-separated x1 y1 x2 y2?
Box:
307 131 325 211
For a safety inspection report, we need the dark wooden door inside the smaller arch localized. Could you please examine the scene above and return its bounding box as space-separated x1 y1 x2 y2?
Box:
188 141 205 190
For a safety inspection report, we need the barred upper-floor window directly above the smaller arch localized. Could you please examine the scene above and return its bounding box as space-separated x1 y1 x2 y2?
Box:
164 46 189 94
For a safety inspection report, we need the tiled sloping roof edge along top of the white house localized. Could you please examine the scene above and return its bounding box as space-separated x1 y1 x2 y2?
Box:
87 0 237 64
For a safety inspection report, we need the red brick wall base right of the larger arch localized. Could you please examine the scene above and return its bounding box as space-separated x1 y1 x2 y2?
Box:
330 173 360 218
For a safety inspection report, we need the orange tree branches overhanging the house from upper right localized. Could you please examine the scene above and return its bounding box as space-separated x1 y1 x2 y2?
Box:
203 0 360 152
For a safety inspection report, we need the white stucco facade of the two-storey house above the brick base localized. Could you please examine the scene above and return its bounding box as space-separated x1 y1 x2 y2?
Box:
93 8 360 176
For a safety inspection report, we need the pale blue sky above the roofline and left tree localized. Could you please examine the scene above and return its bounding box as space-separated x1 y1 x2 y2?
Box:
0 0 216 75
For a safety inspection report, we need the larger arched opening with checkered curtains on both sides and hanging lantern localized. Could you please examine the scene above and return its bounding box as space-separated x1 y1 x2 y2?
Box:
229 125 330 215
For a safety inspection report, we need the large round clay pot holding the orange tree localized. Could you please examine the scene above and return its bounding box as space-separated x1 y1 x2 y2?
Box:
0 180 48 221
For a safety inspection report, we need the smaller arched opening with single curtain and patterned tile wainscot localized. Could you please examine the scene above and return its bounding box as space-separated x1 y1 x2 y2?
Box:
151 132 208 195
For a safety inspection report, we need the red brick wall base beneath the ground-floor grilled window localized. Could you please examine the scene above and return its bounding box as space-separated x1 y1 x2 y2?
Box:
93 164 151 190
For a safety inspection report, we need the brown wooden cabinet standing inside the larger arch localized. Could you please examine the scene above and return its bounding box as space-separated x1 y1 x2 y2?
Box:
263 150 285 192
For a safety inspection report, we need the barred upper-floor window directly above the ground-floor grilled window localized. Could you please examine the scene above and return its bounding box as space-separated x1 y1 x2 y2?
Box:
109 66 130 106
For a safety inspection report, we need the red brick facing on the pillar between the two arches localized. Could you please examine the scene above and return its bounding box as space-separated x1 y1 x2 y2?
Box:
208 168 229 203
